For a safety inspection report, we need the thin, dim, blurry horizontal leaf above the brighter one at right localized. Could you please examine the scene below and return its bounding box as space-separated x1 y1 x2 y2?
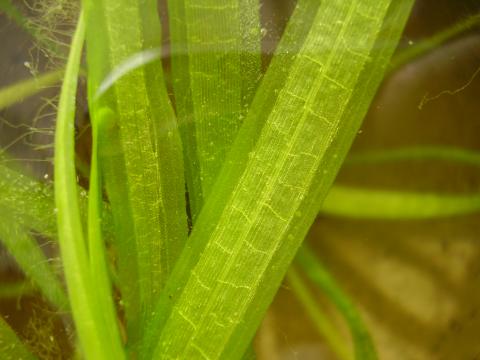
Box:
345 146 480 166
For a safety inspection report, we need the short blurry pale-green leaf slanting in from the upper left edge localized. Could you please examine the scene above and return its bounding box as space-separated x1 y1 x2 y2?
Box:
0 69 63 110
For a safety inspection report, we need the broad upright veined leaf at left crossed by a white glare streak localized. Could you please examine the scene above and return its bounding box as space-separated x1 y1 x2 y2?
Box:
83 0 187 341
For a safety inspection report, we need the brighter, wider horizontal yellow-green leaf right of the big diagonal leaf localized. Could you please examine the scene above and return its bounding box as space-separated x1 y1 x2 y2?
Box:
321 186 480 220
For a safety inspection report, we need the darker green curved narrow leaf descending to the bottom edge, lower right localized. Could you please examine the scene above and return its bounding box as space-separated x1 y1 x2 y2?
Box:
296 245 377 360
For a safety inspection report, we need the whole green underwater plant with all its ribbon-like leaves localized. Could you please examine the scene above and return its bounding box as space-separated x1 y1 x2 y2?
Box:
0 0 480 360
